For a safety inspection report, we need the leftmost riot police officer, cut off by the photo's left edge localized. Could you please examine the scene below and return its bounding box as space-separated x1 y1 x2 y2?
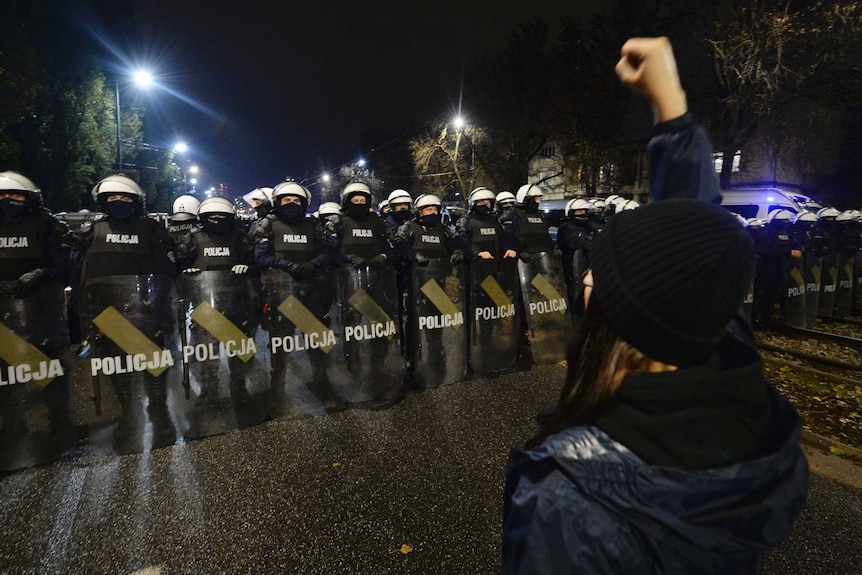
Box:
0 172 74 470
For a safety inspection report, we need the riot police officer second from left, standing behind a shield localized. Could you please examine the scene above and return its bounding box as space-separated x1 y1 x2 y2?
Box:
72 175 179 452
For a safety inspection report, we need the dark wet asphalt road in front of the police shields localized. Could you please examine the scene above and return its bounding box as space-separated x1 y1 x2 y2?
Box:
0 366 862 575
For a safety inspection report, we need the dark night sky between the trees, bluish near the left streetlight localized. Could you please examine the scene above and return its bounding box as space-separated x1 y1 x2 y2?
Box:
130 0 597 200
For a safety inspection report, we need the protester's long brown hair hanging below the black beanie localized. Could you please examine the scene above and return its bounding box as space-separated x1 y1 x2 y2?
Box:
525 297 652 449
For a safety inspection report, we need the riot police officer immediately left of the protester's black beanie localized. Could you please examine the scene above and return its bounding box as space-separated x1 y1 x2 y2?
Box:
557 198 595 306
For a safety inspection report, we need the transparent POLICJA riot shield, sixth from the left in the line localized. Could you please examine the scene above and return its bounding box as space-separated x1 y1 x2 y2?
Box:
408 259 467 388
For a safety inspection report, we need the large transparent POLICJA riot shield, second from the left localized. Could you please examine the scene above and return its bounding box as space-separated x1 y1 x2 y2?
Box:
80 275 185 453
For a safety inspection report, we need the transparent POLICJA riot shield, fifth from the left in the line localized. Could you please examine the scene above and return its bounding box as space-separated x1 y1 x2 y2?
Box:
338 266 403 408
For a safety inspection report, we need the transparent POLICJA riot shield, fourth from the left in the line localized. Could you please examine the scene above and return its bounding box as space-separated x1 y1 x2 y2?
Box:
263 266 345 419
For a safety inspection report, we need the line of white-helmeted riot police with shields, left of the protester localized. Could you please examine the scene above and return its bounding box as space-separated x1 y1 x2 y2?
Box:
0 172 570 470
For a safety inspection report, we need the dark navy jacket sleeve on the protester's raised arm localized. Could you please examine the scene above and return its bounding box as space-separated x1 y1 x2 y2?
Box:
648 114 721 204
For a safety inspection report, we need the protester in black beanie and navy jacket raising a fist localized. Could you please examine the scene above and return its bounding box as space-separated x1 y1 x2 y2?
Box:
503 38 808 573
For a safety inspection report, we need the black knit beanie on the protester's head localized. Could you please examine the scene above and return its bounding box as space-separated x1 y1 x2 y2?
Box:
590 200 754 367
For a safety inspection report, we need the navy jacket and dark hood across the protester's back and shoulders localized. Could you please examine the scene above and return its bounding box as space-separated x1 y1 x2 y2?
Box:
503 335 808 574
